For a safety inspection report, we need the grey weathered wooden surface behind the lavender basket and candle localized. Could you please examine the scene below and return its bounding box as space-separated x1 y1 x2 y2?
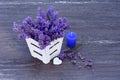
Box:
0 0 120 80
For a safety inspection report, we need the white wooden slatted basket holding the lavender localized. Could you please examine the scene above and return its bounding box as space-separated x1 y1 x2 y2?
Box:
26 38 63 64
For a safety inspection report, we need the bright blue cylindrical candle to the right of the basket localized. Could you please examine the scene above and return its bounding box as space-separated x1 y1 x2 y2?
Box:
66 32 77 48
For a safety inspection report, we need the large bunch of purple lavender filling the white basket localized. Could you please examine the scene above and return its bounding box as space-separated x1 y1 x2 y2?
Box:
13 7 70 49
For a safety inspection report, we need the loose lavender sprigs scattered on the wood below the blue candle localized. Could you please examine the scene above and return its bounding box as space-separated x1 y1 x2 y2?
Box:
58 48 93 69
